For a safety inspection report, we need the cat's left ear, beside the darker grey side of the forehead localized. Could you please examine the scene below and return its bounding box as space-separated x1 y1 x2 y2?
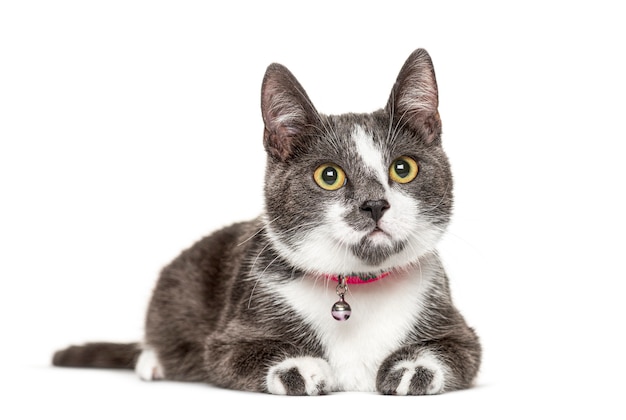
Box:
261 64 318 161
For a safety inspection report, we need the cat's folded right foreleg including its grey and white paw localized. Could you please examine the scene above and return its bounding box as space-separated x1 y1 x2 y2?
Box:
376 342 480 395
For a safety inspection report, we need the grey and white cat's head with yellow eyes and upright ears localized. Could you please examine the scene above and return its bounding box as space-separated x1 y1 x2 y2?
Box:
261 50 452 275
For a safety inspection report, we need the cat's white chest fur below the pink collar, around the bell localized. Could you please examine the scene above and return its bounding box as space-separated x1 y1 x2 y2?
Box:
276 268 432 391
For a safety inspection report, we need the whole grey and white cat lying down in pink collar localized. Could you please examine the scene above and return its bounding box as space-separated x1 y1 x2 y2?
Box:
53 49 481 395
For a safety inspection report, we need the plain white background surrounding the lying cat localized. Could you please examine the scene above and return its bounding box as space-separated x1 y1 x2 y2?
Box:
0 0 626 419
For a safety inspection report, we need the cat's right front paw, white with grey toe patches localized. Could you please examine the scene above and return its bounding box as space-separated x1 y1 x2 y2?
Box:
376 353 446 395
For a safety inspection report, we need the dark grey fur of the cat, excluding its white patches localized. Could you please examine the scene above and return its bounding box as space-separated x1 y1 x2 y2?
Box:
53 50 481 395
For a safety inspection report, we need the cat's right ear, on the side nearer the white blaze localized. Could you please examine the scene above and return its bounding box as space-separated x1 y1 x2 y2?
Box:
386 49 441 143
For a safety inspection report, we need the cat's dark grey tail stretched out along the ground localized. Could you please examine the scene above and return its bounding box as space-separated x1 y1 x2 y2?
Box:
52 343 141 369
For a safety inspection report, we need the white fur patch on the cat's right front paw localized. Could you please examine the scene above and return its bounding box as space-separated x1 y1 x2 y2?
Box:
392 352 446 395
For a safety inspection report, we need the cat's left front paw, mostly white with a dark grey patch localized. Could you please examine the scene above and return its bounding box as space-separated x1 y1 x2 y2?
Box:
266 357 333 395
